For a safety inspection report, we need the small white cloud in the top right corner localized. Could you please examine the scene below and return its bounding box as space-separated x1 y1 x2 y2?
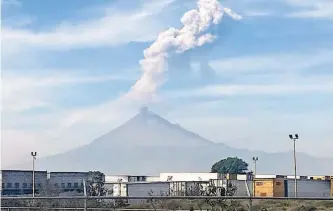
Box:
285 0 333 20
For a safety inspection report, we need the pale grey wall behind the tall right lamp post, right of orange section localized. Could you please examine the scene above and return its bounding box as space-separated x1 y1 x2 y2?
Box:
287 180 331 197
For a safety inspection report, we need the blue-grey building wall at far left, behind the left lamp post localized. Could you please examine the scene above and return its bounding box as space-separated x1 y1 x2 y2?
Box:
1 170 47 195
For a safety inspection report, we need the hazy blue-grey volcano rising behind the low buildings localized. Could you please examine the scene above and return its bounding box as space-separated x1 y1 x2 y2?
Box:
11 107 333 175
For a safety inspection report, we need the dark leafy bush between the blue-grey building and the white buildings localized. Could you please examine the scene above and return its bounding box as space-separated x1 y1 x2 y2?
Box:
86 171 107 196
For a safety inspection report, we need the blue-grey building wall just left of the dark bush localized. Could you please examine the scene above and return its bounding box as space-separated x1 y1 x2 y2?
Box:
49 172 88 192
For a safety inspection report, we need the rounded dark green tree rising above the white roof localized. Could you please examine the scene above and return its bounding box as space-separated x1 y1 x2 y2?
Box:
211 157 249 174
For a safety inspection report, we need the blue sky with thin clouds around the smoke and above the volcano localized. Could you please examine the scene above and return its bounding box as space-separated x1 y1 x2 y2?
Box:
1 0 333 165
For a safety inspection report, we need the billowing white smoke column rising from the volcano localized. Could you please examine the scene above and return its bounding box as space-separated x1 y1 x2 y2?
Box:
128 0 242 102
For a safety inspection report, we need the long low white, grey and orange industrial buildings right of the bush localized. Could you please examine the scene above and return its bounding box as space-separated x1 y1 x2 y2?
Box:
102 173 333 197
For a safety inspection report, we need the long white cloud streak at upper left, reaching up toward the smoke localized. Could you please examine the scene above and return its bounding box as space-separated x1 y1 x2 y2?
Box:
1 0 172 56
